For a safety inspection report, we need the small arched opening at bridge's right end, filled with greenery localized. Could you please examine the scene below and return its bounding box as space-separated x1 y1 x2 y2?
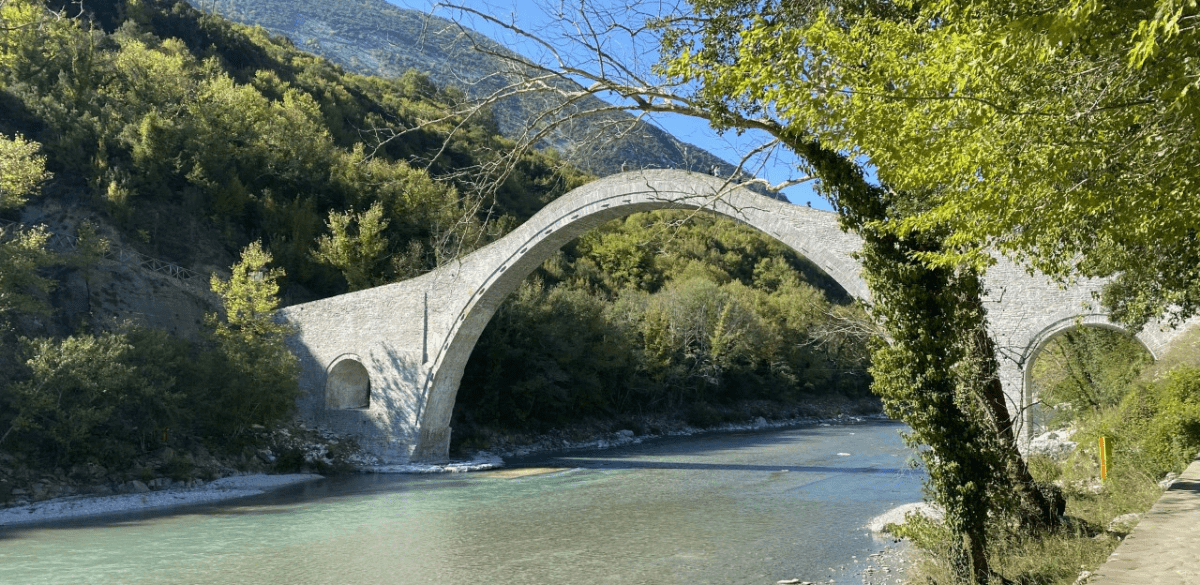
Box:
1026 325 1154 436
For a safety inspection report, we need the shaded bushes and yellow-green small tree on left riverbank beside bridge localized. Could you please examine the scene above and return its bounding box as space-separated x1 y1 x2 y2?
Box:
0 236 298 465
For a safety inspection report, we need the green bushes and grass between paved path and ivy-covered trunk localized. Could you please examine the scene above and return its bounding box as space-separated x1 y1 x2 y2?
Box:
921 342 1200 585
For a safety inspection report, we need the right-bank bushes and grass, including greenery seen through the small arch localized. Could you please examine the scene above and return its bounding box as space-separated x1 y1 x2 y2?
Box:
892 327 1200 585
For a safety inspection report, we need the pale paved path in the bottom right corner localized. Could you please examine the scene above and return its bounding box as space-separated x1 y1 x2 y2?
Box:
1087 457 1200 585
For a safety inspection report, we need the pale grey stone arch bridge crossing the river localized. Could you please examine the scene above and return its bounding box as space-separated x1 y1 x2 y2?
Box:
280 170 1177 463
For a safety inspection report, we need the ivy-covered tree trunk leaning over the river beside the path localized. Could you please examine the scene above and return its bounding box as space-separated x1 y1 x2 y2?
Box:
786 131 1061 583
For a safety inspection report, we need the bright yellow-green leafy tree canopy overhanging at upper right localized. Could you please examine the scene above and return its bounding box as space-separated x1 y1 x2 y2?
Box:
659 0 1200 325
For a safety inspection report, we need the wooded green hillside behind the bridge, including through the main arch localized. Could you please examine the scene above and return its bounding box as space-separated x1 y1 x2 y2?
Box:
0 0 870 501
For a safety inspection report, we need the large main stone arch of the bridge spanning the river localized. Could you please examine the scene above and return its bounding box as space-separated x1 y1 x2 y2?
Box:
415 170 868 457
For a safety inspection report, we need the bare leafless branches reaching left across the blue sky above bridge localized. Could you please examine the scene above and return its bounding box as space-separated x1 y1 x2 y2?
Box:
364 0 814 213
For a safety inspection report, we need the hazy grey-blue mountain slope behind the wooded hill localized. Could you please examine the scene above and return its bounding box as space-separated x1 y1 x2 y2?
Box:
180 0 758 184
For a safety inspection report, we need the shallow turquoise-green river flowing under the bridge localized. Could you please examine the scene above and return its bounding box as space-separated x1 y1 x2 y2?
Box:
0 421 922 585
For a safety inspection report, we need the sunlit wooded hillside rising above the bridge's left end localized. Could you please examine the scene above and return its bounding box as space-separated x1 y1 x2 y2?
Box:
0 0 587 294
